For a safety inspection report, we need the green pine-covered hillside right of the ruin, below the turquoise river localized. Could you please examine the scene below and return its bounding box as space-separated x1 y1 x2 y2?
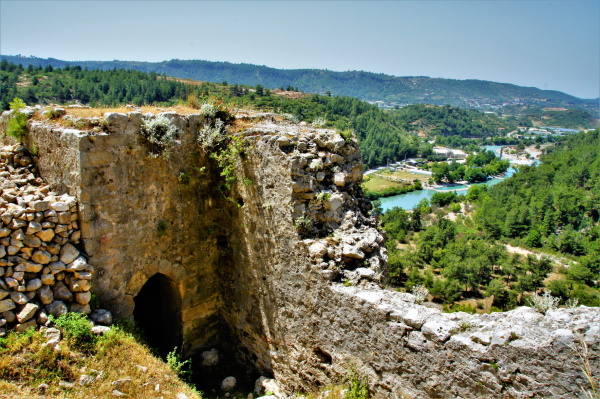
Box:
382 130 600 311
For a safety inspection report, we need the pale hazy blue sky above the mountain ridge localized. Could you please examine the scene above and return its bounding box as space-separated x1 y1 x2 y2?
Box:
0 0 600 98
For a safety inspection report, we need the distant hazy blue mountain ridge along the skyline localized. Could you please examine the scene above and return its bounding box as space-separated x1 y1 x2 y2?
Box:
0 55 598 110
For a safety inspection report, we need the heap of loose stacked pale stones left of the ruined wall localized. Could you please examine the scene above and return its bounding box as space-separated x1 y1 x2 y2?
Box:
0 145 94 335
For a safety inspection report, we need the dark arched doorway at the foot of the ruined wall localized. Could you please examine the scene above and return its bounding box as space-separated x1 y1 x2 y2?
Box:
133 273 182 356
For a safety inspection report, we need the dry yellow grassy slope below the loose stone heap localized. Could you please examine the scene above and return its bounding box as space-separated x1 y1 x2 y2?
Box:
0 329 200 399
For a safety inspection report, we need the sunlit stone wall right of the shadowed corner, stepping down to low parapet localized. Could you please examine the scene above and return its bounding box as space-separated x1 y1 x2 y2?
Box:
216 119 600 398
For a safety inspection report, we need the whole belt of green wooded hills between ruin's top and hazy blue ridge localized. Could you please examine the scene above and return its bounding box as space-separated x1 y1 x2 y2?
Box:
0 60 580 175
